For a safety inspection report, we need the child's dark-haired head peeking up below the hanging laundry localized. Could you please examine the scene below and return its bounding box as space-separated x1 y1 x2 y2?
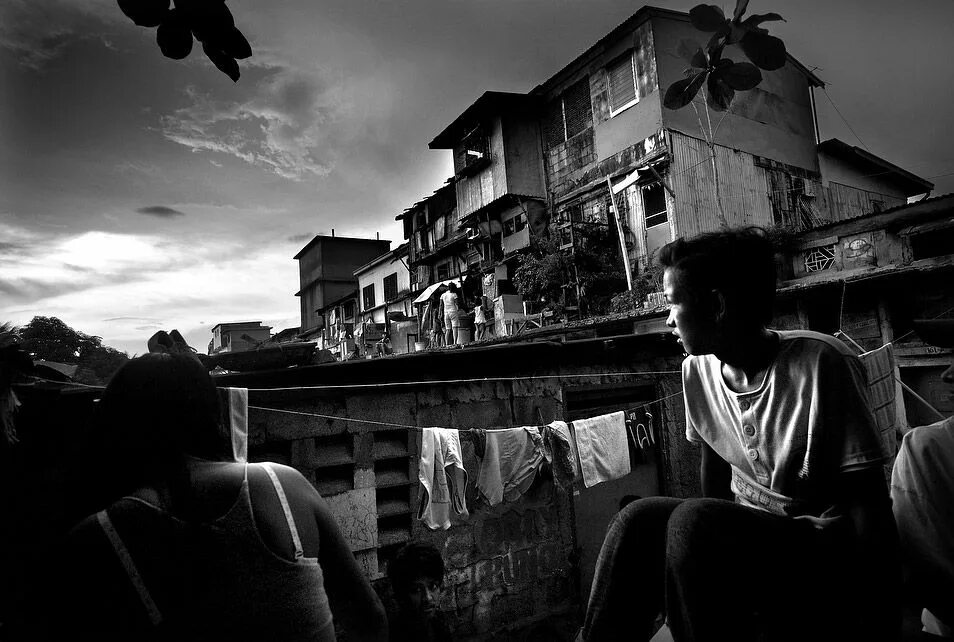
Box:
388 542 444 613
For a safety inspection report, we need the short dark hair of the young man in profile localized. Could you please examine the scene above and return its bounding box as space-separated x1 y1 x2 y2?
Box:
659 227 776 325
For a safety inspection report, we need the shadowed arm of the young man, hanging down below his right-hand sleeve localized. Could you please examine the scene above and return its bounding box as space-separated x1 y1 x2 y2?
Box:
837 465 901 640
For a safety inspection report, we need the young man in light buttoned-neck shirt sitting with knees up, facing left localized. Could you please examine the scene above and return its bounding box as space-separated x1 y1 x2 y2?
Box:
582 228 900 641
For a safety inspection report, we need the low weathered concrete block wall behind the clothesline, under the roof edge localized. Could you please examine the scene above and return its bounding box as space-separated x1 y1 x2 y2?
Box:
219 336 694 640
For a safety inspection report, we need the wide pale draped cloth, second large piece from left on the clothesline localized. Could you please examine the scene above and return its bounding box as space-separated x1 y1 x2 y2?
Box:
477 426 544 506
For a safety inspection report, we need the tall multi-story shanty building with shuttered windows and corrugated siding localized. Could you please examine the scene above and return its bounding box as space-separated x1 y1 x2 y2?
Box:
418 7 932 312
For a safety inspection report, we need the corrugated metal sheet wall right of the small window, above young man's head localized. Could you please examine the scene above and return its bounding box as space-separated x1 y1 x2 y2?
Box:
667 131 775 237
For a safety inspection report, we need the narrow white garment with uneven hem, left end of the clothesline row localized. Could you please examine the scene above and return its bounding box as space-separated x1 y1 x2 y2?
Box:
417 428 468 530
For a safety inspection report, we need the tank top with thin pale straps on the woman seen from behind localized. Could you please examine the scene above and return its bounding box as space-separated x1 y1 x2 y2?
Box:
96 464 333 640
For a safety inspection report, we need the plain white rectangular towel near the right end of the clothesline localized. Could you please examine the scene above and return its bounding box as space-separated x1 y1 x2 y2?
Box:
573 412 631 488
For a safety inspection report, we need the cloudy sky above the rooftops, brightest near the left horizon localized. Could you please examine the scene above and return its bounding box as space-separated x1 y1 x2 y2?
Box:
0 0 954 354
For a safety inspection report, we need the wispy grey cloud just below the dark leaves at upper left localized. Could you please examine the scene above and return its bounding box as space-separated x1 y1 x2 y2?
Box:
161 56 339 181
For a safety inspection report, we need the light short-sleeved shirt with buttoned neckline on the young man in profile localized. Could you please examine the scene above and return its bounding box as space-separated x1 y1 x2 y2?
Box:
682 330 883 516
